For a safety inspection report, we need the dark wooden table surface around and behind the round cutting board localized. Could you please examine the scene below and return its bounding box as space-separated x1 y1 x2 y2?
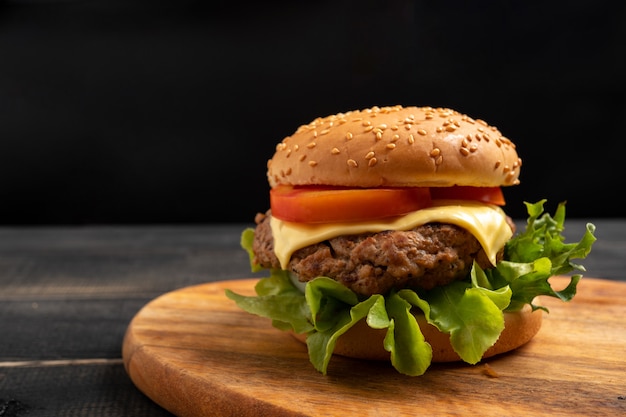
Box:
0 219 626 417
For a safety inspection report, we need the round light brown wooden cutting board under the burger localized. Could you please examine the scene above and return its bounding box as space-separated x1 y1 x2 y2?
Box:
123 277 626 417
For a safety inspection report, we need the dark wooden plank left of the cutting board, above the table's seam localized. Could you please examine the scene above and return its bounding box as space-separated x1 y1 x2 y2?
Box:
0 225 250 362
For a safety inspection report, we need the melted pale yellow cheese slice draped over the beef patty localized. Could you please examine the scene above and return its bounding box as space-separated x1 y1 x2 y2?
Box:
270 200 513 269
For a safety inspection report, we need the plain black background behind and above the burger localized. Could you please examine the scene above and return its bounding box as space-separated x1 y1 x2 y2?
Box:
0 0 626 225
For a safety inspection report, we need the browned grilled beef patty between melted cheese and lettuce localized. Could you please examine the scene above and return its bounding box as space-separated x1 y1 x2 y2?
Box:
253 210 514 296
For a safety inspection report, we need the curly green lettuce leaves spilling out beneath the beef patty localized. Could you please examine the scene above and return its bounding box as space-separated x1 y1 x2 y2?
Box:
226 200 596 376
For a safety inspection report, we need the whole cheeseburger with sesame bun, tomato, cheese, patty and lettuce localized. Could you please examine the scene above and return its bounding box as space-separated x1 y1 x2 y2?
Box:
226 106 595 376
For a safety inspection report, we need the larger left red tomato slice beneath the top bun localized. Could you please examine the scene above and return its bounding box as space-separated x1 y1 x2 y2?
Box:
270 185 431 223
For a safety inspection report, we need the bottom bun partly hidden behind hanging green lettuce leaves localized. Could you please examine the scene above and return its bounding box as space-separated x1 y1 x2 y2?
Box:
292 305 542 362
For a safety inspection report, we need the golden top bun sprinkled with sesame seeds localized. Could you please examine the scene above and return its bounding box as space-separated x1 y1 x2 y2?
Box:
267 106 522 187
